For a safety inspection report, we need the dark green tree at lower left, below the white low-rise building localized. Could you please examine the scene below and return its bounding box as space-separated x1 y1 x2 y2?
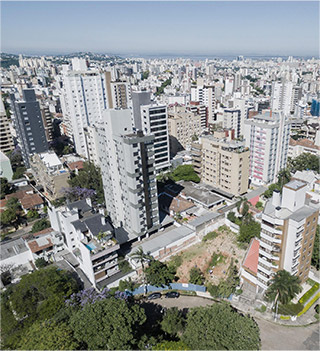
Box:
10 266 78 321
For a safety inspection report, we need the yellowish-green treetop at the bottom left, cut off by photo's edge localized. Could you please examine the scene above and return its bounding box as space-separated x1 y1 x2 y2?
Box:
18 321 80 350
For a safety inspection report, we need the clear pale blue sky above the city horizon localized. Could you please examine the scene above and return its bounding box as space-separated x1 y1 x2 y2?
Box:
1 1 319 56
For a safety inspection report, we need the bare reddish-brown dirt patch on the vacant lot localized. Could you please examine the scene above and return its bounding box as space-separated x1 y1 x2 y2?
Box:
177 229 246 284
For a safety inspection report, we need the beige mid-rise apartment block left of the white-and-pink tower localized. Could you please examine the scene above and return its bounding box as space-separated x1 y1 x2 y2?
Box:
191 131 250 196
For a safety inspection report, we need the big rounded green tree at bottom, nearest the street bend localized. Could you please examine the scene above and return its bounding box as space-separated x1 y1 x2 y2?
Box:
182 303 260 350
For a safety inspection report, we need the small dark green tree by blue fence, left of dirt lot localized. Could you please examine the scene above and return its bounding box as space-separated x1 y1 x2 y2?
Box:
144 260 176 286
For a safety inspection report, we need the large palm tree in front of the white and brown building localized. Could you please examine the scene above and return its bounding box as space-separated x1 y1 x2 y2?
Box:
266 269 302 305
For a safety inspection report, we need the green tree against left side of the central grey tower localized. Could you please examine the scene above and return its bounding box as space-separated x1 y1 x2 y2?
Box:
69 162 104 204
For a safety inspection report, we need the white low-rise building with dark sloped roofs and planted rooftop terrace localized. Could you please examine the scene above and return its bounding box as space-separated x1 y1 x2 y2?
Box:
48 200 120 287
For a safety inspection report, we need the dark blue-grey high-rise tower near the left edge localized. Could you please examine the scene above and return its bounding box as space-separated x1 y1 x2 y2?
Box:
11 89 49 168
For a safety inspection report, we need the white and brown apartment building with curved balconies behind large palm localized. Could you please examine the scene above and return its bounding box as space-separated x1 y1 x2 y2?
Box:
241 180 319 292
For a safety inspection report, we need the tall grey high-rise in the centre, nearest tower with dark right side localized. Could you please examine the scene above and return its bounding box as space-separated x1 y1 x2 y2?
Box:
96 109 159 240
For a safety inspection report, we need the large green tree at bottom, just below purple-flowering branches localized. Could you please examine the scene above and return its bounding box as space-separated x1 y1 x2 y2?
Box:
70 297 146 350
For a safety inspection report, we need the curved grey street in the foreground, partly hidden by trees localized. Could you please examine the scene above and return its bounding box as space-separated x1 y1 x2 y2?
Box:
143 296 320 350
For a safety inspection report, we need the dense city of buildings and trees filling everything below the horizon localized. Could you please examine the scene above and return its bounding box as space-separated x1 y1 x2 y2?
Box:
0 0 320 350
